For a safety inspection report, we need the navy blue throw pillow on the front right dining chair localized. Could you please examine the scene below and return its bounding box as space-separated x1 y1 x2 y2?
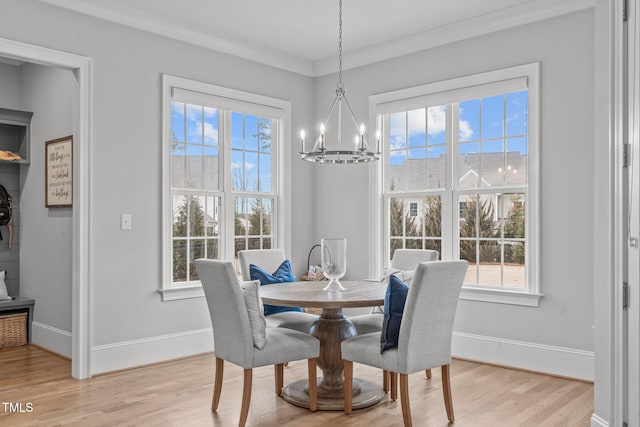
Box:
380 275 409 353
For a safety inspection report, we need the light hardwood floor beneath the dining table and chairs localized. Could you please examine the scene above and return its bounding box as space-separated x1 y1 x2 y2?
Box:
0 346 593 427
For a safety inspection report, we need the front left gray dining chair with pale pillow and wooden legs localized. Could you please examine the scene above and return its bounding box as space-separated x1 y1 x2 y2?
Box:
194 259 320 427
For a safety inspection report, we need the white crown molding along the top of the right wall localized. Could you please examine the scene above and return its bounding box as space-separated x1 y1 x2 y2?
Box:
313 0 595 77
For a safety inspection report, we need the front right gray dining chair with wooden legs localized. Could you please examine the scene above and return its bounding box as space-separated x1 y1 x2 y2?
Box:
342 261 468 426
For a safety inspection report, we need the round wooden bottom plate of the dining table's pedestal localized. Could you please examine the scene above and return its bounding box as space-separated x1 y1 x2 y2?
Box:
282 378 385 411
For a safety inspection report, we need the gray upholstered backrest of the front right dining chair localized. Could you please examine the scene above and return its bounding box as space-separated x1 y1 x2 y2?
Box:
398 261 469 372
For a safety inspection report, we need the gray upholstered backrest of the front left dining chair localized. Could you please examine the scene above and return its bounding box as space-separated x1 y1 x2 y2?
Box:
194 259 253 368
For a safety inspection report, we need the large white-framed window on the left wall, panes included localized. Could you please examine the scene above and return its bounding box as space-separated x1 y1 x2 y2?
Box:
161 76 289 299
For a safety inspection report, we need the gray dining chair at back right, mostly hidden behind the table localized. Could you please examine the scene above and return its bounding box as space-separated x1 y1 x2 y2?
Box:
344 249 440 335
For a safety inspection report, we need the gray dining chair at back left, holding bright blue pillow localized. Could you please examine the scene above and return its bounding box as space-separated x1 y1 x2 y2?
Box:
238 249 318 333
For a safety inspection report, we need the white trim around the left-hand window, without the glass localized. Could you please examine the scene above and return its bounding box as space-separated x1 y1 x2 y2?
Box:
158 74 292 301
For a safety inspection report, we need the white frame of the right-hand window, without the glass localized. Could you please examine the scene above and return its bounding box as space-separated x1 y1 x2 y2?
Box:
369 62 543 307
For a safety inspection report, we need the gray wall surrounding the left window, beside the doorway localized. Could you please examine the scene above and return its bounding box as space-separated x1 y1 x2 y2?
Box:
0 0 314 352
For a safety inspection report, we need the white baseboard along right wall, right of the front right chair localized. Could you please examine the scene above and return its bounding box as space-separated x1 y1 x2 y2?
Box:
451 332 595 381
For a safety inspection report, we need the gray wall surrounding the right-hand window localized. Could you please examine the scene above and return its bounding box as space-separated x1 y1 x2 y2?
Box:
315 10 594 351
